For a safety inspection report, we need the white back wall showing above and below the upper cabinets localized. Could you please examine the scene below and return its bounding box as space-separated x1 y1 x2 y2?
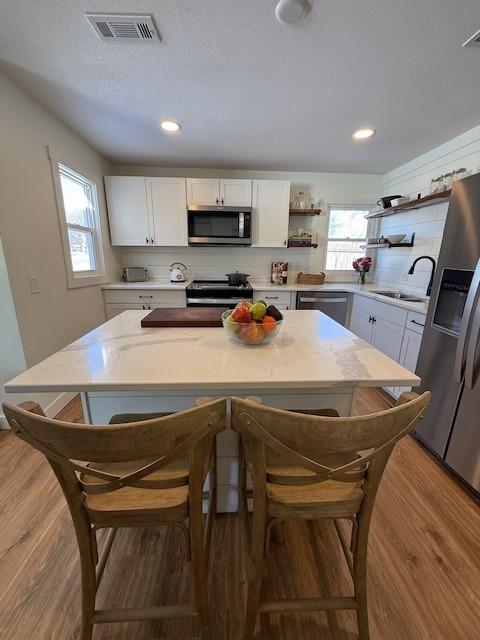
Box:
112 166 382 282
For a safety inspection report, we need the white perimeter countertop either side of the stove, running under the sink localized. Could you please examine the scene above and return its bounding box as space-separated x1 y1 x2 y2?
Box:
102 280 428 314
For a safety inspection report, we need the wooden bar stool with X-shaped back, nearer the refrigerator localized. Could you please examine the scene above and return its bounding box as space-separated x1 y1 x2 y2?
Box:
232 392 431 640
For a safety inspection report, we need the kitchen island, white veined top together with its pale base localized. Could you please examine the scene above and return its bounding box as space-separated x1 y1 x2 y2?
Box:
5 311 420 511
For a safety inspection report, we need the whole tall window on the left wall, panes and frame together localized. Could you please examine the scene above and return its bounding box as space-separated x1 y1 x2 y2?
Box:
54 163 104 287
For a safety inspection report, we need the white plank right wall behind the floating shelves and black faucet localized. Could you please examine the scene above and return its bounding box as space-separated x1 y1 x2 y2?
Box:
372 126 480 295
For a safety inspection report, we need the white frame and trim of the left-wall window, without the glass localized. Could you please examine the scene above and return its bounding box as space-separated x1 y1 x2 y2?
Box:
49 153 106 289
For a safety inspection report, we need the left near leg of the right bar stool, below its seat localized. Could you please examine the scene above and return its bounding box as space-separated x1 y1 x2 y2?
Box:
243 509 266 640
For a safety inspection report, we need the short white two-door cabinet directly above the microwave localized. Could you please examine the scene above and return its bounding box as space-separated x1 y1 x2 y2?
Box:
187 178 252 207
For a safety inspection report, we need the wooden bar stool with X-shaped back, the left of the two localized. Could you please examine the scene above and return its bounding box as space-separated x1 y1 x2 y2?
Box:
3 399 226 640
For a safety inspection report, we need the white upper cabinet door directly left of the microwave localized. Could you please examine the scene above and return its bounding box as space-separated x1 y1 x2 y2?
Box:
147 178 188 247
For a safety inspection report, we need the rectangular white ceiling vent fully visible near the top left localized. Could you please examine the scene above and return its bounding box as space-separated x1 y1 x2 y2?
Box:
85 13 161 42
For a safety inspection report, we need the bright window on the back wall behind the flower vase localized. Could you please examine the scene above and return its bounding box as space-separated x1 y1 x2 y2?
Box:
325 207 370 271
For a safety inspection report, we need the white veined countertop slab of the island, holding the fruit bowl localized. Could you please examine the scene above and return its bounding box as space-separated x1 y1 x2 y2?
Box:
5 311 420 393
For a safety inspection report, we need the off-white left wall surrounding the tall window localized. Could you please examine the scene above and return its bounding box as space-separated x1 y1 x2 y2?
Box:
0 74 119 410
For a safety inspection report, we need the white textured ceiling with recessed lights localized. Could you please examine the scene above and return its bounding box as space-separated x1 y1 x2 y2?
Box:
0 0 480 173
